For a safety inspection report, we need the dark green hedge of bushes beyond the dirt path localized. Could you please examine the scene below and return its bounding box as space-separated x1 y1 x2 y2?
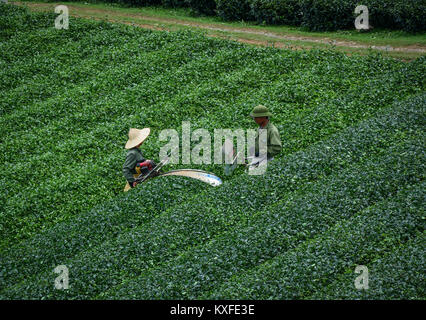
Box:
36 0 426 32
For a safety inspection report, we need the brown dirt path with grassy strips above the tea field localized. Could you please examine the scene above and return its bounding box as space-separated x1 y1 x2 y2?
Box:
11 1 426 54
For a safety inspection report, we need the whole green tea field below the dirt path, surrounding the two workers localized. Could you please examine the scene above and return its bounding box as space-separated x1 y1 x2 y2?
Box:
0 4 426 299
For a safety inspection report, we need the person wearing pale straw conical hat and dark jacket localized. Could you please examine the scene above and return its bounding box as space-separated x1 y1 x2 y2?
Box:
123 128 155 191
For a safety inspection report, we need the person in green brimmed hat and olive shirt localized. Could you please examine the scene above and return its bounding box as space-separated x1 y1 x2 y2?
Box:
250 105 283 160
